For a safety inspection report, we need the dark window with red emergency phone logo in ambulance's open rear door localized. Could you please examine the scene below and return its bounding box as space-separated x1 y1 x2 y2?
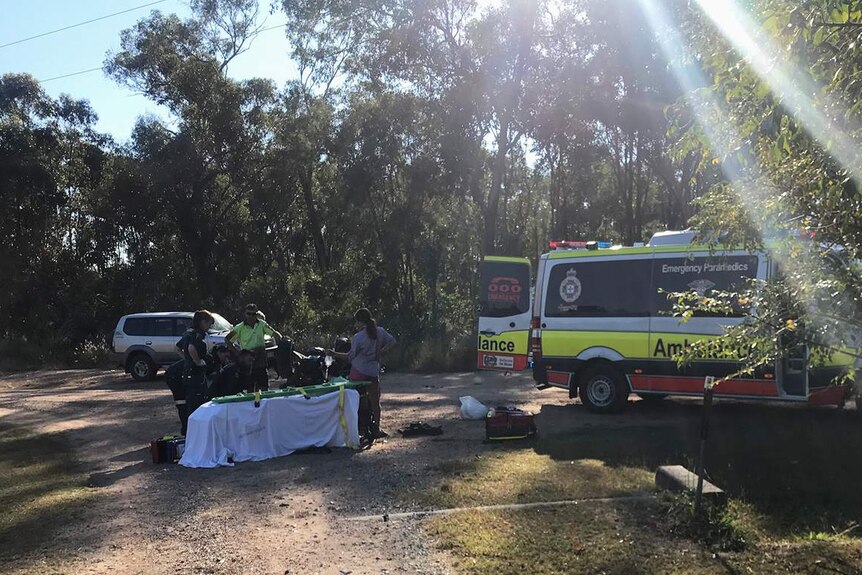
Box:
479 261 530 317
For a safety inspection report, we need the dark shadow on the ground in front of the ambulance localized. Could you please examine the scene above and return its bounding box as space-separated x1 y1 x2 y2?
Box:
535 401 862 533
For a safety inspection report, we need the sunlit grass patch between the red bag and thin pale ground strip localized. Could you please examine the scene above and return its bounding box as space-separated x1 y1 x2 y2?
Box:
410 449 653 508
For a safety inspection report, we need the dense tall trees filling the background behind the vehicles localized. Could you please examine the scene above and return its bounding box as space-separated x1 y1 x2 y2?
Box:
0 0 862 374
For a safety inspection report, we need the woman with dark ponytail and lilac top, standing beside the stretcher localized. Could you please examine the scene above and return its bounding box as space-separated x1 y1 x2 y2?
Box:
328 307 397 438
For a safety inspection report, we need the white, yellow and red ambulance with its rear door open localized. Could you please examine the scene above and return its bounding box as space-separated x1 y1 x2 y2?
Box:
478 231 853 413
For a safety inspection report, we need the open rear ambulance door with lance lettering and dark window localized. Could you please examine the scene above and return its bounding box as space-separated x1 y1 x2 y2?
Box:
478 256 532 371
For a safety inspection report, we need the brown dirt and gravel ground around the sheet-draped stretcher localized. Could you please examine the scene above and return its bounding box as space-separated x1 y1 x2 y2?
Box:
0 370 855 575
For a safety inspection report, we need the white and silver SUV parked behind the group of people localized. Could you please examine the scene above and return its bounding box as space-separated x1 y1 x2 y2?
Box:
113 311 235 381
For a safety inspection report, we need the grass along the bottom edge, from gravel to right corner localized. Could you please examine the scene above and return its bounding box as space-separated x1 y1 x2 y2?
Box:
424 502 862 575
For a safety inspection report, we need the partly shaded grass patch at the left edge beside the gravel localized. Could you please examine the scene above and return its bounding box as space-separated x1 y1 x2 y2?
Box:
0 427 96 564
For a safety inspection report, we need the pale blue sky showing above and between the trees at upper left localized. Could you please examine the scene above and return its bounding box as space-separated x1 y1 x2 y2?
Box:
0 0 296 142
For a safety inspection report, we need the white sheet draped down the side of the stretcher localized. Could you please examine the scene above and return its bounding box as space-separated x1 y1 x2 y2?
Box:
180 389 359 467
